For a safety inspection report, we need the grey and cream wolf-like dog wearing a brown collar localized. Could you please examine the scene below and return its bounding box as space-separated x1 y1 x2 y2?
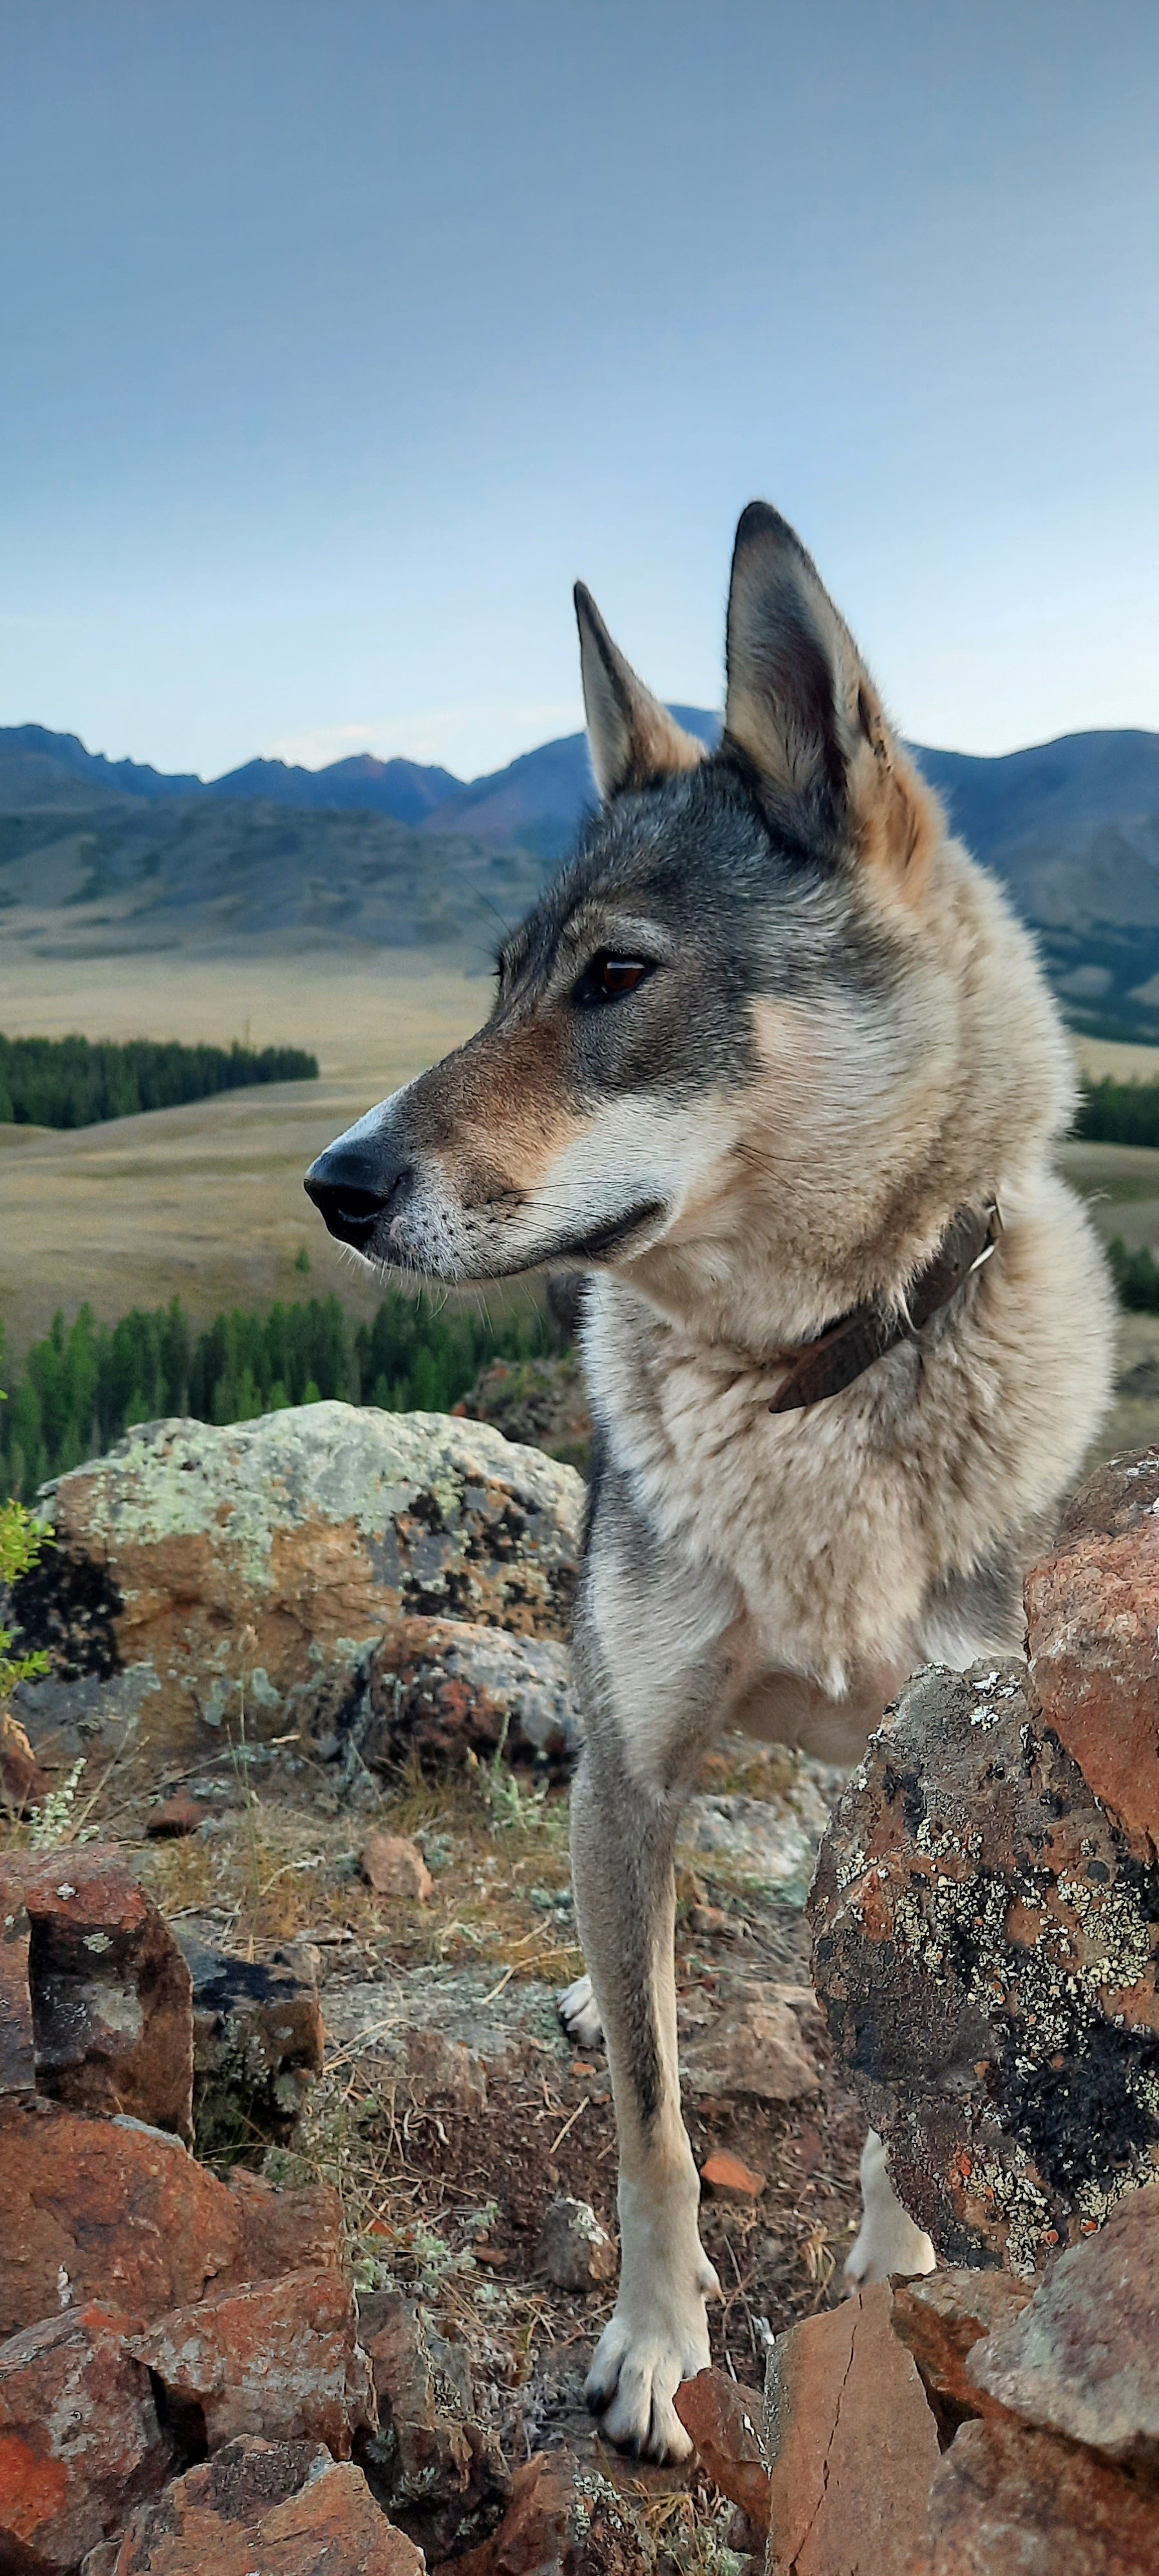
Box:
306 502 1113 2460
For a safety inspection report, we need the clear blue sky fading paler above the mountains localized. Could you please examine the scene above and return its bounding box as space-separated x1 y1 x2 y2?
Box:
0 0 1159 775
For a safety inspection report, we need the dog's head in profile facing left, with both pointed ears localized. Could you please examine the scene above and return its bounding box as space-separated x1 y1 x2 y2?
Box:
306 502 974 1319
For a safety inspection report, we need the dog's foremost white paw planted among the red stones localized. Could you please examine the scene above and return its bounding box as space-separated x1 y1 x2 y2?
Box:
585 2254 721 2460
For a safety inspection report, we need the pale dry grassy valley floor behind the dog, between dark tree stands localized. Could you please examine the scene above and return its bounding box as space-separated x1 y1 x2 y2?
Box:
0 951 1159 1453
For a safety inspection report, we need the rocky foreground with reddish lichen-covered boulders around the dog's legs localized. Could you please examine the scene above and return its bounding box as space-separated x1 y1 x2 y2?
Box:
0 1406 1159 2576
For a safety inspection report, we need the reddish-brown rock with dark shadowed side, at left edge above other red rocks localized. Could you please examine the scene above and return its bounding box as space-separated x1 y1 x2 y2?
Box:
0 1844 193 2136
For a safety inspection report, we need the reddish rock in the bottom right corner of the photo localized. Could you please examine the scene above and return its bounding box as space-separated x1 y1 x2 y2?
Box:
917 2419 1159 2576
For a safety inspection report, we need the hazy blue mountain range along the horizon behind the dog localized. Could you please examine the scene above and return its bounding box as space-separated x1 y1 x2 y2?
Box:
0 706 1159 1036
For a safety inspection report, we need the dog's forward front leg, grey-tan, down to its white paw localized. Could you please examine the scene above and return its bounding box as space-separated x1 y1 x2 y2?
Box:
572 1739 719 2460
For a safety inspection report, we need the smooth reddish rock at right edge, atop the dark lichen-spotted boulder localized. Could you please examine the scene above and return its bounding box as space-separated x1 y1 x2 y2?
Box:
1025 1450 1159 1862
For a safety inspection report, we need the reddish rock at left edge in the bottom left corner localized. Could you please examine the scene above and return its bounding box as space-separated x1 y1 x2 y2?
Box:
0 2303 170 2576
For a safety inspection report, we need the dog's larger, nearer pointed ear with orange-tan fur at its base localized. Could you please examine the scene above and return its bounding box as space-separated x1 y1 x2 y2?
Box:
724 500 943 896
